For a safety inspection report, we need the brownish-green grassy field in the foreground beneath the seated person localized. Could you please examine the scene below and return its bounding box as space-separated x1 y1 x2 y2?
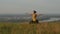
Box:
0 21 60 34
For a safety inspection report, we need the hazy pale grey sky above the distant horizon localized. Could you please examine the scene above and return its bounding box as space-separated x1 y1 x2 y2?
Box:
0 0 60 14
